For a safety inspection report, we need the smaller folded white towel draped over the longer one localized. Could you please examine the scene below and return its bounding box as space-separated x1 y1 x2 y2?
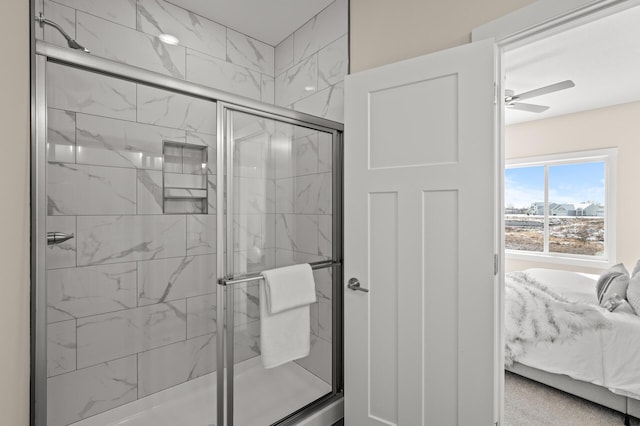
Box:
262 263 316 314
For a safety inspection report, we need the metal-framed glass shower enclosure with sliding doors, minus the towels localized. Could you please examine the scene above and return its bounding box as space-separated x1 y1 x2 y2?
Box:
32 42 342 426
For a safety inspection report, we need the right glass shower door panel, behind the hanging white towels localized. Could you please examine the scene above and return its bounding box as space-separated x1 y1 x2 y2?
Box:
219 110 339 426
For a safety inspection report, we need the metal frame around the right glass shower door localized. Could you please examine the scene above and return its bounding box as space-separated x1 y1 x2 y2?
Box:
216 101 343 426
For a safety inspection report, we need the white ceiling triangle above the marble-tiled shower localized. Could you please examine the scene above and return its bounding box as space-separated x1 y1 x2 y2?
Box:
169 0 333 46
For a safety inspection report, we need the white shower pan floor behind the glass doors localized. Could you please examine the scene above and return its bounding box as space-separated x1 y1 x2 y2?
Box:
73 357 331 426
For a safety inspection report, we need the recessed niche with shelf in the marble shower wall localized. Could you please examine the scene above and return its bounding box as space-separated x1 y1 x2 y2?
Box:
162 141 209 214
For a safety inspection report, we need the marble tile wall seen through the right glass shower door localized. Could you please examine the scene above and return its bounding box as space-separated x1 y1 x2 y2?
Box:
233 114 333 383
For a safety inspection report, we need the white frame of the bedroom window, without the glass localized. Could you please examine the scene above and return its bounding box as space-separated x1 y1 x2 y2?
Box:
502 148 618 268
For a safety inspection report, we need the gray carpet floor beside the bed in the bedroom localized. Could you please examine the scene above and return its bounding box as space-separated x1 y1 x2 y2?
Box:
504 371 640 426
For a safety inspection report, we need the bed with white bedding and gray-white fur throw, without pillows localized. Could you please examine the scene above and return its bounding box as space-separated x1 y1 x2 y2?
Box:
505 269 640 417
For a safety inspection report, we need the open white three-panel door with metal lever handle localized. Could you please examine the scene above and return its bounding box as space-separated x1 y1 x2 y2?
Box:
344 38 497 426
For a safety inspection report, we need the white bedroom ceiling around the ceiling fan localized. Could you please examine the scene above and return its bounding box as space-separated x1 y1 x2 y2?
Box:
504 7 640 124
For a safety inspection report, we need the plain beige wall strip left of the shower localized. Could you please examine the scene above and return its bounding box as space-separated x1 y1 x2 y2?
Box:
0 1 30 426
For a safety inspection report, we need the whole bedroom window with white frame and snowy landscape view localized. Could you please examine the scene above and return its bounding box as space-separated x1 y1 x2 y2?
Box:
504 149 616 263
